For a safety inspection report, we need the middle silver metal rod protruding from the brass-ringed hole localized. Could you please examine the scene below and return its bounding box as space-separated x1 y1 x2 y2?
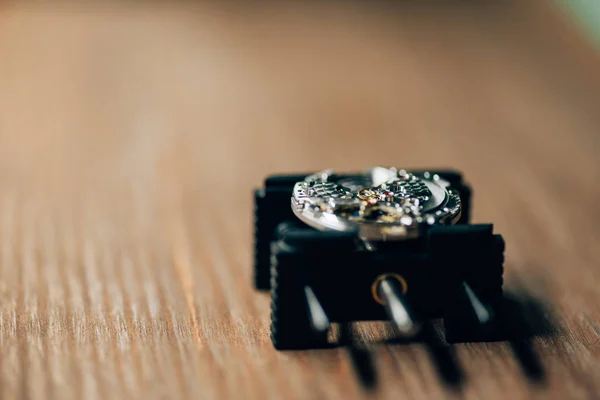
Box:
377 278 421 338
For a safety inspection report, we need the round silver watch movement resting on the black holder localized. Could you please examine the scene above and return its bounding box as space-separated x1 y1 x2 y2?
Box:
292 167 461 241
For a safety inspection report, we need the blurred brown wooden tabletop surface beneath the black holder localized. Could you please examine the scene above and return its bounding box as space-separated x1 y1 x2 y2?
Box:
0 0 600 399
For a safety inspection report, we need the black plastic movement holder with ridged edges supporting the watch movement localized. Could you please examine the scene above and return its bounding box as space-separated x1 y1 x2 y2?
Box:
254 171 504 350
